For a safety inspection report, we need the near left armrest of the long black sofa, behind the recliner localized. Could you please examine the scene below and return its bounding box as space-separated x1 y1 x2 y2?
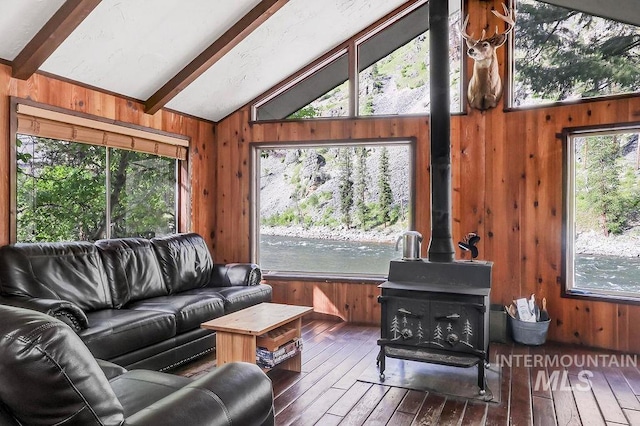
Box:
0 295 89 332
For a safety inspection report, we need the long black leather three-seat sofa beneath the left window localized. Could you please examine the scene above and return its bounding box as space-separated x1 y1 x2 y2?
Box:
0 233 271 371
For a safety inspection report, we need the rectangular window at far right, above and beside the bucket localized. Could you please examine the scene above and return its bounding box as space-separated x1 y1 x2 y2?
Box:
565 126 640 298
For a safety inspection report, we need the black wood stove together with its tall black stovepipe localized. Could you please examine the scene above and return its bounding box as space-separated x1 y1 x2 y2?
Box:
378 0 492 394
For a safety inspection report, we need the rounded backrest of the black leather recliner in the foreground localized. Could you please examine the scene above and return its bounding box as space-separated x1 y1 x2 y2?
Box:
0 305 124 426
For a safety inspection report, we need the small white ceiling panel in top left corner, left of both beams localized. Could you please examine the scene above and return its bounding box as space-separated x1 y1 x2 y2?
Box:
0 0 64 61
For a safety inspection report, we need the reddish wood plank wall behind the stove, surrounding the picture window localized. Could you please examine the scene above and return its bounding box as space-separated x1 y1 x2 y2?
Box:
214 0 640 352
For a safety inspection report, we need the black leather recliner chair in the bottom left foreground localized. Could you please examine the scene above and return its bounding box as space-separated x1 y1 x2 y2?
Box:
0 306 274 426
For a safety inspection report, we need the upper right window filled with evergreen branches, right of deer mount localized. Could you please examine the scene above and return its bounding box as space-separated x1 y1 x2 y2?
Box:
512 0 640 106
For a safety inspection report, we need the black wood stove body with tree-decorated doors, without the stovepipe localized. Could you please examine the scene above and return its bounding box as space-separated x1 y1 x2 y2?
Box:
378 260 492 394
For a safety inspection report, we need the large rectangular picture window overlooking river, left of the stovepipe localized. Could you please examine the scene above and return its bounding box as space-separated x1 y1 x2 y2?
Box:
252 141 413 276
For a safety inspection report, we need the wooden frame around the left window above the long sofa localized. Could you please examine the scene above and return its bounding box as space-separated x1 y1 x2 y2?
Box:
9 96 191 244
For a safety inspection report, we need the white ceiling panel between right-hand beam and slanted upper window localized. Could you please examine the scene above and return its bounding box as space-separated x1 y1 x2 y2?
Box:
167 0 404 121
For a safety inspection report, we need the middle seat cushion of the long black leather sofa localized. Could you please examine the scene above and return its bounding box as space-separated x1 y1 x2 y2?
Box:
127 292 225 333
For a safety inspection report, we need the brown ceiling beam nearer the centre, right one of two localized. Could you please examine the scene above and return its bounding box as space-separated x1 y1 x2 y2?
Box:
145 0 289 114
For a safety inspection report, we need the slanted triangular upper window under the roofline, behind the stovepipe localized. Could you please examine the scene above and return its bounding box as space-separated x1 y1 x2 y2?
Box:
253 2 461 120
